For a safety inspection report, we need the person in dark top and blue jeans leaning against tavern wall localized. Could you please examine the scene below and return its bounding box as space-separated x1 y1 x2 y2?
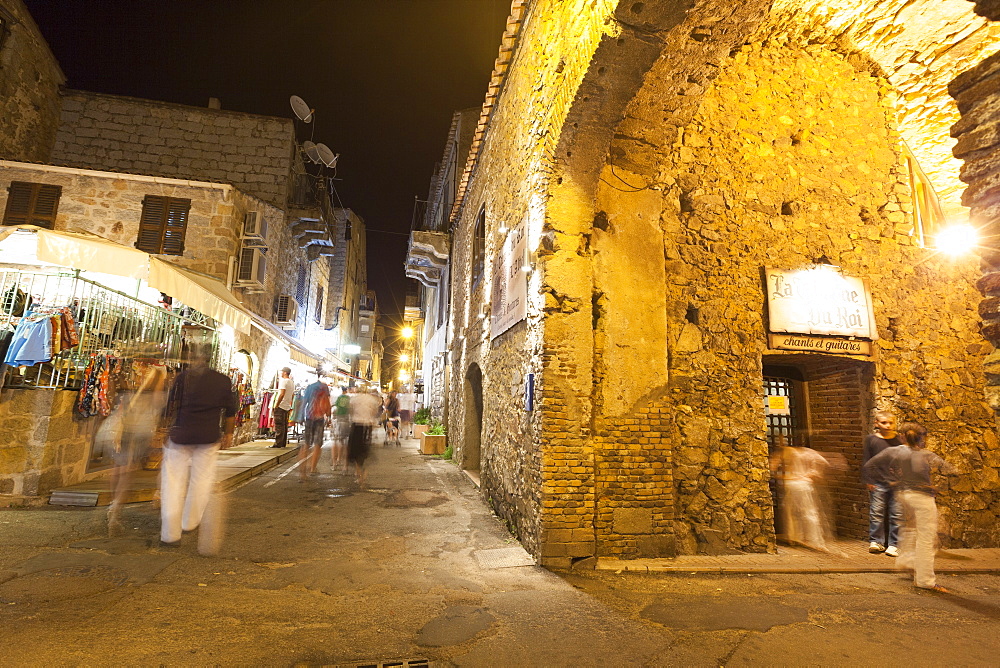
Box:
861 411 903 557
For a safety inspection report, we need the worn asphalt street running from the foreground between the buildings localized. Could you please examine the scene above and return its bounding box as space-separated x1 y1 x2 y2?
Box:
0 441 1000 666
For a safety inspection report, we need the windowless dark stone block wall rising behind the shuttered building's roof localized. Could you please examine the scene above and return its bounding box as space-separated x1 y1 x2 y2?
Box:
52 91 295 209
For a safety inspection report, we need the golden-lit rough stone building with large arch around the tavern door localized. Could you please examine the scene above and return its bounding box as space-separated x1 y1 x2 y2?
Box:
449 0 1000 566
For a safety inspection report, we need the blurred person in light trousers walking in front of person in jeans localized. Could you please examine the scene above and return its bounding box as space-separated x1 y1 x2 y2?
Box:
864 422 954 593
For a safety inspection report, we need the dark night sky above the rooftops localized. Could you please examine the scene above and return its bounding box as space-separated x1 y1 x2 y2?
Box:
25 0 510 324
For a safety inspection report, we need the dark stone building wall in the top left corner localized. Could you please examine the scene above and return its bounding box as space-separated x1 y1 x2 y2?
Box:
0 0 66 162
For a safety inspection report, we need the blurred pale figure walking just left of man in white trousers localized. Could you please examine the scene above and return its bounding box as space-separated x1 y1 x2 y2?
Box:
108 364 167 535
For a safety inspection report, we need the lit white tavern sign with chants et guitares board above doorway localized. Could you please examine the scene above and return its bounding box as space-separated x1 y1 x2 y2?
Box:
765 265 878 355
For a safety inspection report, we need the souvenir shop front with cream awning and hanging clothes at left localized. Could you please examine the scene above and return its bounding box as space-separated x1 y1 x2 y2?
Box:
0 229 255 501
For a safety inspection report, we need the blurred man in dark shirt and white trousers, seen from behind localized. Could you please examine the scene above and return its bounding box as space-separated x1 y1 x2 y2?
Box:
160 346 237 552
